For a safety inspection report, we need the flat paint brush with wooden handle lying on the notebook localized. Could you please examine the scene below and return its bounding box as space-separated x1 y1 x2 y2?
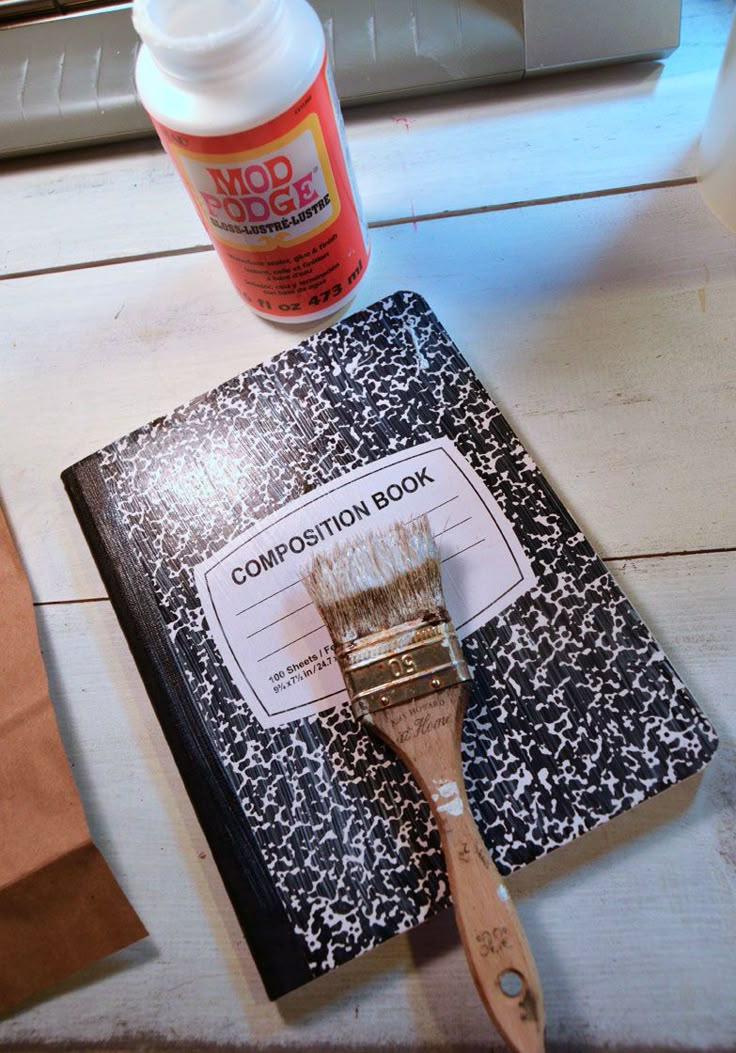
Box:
303 516 544 1053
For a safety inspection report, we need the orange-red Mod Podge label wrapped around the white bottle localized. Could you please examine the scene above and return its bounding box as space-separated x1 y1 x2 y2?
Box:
154 58 369 318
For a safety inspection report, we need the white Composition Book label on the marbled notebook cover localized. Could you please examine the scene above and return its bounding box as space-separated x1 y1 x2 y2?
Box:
194 439 535 728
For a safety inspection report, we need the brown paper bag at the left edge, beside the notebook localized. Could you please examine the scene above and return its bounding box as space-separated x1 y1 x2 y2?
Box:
0 510 146 1013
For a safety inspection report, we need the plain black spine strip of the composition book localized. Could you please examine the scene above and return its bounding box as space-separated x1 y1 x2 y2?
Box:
61 457 315 999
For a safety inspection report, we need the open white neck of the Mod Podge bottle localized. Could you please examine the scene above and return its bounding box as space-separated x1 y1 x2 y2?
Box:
133 0 283 80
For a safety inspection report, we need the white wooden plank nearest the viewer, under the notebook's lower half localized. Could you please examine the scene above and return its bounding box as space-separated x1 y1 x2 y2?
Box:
0 553 736 1050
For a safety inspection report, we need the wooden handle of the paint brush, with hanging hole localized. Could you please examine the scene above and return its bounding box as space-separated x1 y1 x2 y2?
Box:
365 687 544 1053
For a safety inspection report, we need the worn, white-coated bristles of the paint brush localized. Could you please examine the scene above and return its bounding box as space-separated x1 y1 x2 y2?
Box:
302 516 447 644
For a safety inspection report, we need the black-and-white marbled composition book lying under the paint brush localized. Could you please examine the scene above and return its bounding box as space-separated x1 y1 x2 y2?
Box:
63 293 716 997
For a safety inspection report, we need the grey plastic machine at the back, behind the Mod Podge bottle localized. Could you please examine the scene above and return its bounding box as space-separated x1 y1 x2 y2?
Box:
0 0 680 157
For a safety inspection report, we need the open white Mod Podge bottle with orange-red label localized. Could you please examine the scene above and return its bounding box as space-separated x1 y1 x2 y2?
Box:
133 0 369 322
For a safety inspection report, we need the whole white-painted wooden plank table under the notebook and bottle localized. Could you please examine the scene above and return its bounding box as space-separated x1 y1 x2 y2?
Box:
0 0 736 1053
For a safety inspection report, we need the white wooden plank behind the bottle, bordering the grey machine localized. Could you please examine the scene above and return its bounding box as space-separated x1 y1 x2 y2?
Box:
0 0 733 275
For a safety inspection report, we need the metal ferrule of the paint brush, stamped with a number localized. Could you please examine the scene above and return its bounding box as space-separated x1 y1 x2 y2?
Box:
337 619 471 719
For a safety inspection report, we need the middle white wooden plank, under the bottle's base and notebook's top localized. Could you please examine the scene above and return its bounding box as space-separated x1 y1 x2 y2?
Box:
0 186 736 601
